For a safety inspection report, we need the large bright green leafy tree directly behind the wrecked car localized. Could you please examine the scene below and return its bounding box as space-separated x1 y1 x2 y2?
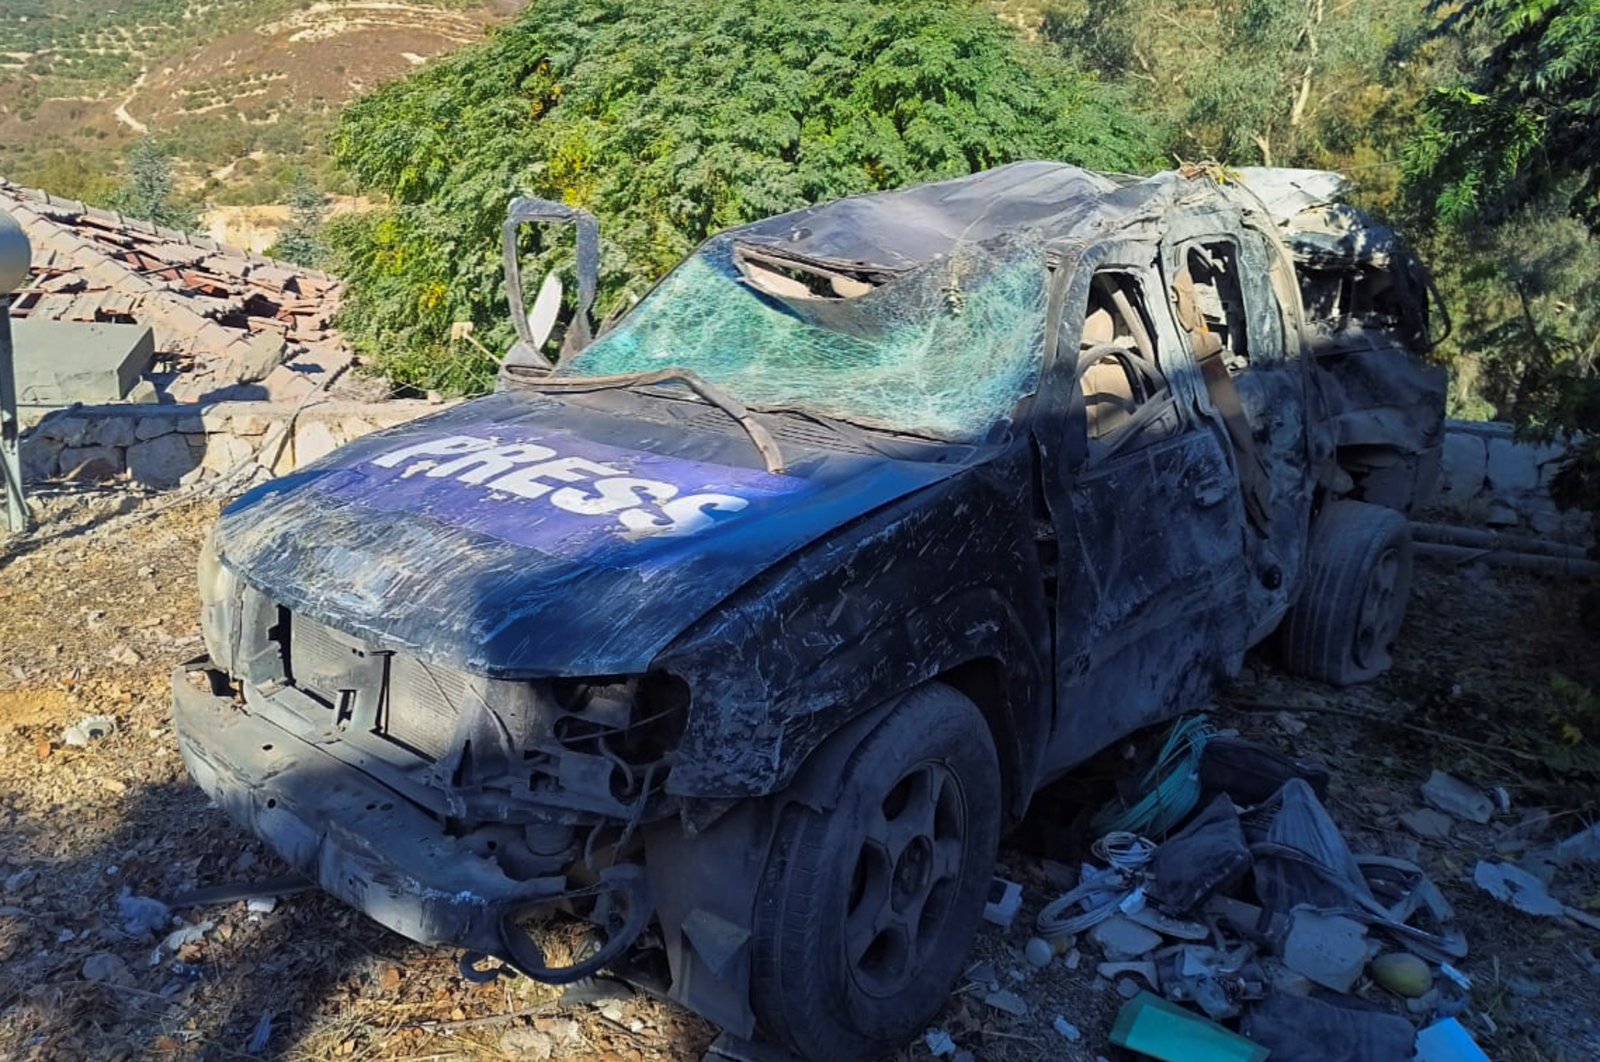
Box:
330 0 1158 389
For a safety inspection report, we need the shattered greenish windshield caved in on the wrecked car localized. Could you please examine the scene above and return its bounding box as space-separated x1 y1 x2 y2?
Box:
557 235 1045 440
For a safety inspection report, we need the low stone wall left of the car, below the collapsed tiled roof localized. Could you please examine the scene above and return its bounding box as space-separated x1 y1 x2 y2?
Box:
22 400 443 489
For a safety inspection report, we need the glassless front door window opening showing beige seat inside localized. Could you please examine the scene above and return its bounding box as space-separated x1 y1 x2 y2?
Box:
1078 272 1166 449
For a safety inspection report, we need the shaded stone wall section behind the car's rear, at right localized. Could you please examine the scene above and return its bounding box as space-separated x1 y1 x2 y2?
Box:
1438 421 1590 541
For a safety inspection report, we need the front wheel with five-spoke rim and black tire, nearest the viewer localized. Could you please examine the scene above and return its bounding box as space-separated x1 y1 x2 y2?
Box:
752 683 1000 1062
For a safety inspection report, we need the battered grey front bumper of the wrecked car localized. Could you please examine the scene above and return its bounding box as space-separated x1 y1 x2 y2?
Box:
173 661 648 982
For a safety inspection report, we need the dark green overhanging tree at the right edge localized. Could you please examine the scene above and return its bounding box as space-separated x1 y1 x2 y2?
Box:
1406 0 1600 527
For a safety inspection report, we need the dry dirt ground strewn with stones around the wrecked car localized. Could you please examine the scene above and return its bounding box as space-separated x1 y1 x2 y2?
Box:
0 491 1600 1062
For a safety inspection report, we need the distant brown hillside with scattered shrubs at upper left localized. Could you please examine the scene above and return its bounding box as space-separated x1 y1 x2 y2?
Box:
0 0 526 203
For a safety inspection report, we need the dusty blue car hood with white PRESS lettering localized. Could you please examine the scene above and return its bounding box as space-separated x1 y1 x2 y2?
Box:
218 393 963 678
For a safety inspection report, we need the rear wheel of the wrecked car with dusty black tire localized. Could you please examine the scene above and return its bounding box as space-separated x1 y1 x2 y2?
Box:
1282 501 1411 686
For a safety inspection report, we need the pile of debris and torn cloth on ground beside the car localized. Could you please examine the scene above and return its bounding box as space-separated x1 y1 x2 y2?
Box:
947 717 1600 1062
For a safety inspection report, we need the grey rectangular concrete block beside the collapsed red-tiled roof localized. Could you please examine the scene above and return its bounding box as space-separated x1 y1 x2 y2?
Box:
11 318 155 403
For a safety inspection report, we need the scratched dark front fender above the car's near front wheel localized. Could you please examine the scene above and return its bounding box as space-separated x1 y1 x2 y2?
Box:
658 462 1051 804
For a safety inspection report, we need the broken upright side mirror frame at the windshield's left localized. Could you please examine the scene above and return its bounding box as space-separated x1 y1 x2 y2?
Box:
504 198 600 369
